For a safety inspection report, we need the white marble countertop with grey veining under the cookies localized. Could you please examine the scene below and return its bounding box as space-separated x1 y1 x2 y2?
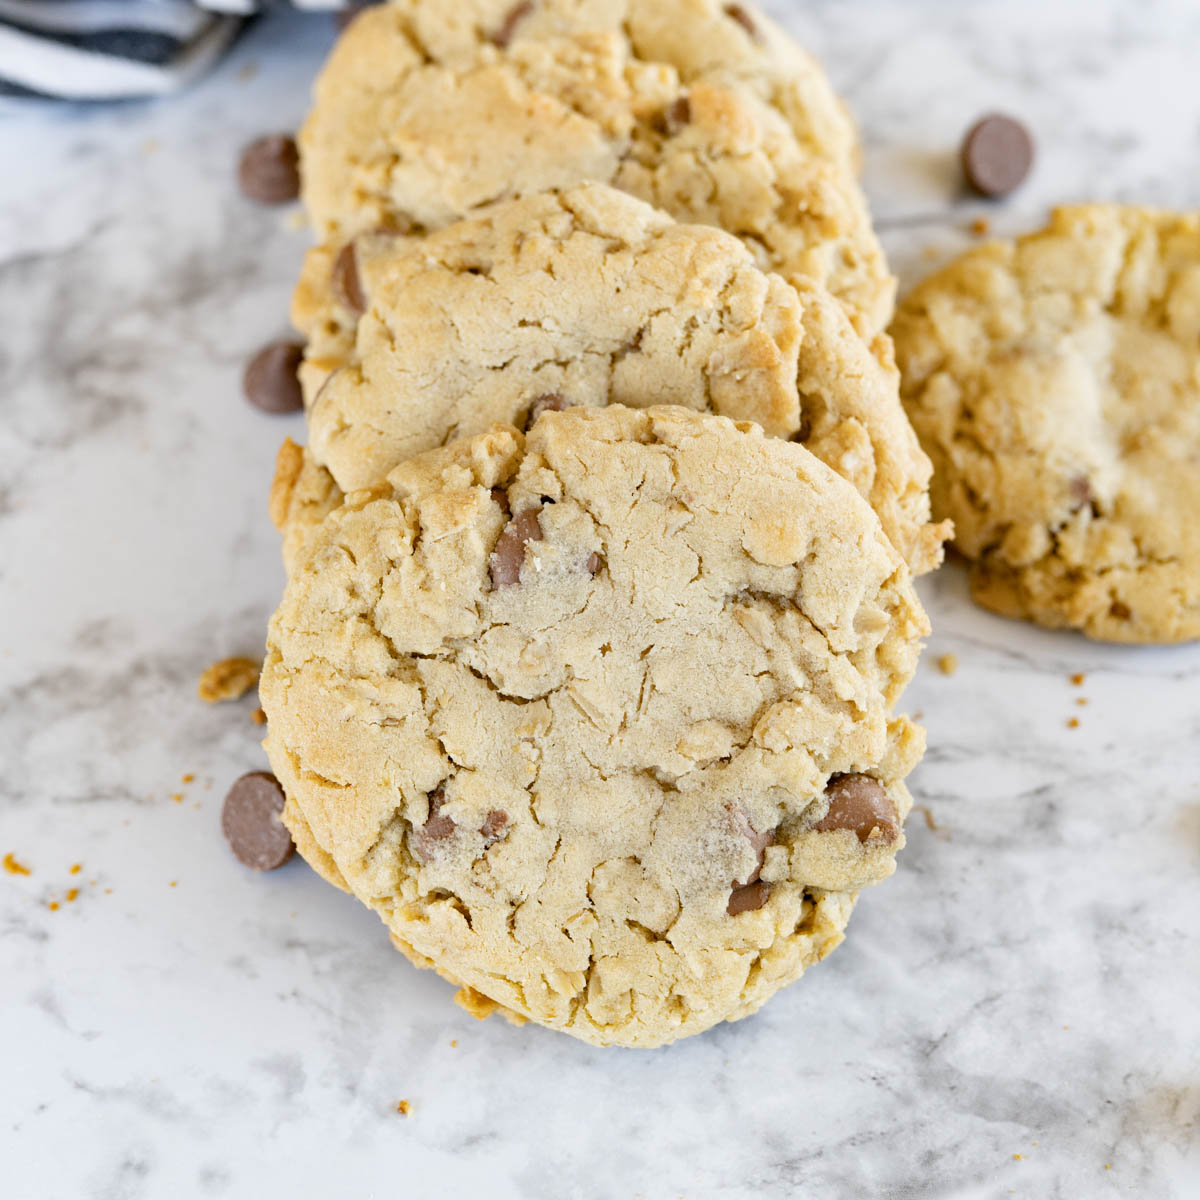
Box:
0 0 1200 1200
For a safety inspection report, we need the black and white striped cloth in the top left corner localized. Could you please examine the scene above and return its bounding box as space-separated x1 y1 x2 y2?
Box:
0 0 345 100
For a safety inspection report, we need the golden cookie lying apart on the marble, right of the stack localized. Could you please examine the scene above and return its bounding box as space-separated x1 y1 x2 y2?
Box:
893 204 1200 642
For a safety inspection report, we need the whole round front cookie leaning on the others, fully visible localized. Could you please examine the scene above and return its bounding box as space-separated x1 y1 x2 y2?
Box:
260 406 926 1046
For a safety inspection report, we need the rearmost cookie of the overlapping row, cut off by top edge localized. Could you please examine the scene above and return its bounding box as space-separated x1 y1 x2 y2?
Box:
296 0 895 337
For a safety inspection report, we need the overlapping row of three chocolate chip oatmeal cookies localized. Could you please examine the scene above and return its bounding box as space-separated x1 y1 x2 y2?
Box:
262 0 947 1046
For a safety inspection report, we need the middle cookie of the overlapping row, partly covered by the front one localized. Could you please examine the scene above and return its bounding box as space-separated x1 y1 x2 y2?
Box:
288 184 944 572
